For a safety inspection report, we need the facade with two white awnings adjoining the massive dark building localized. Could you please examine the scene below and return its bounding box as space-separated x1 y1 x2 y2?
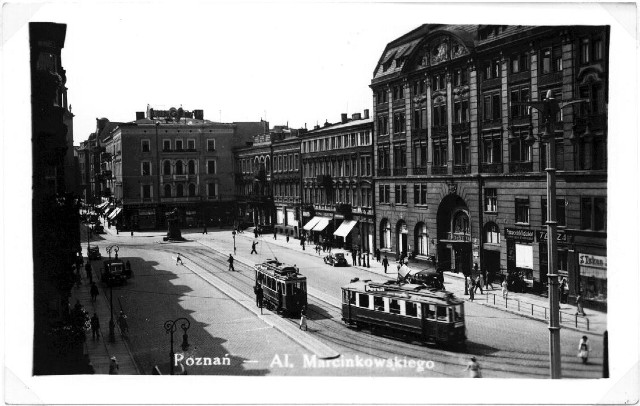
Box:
300 110 375 252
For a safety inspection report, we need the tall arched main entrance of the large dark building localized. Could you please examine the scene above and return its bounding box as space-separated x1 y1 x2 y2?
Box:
436 194 472 274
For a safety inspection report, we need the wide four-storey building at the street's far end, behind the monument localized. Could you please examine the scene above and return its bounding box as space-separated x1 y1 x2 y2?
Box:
95 107 263 230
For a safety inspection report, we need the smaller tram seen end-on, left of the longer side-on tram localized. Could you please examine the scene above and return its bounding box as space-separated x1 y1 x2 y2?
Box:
254 259 307 317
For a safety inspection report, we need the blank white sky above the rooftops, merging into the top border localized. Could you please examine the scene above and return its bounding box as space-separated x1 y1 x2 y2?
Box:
16 3 444 144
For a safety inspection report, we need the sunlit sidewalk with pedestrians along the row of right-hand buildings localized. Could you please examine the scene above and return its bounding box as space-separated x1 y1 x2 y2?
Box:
229 229 607 334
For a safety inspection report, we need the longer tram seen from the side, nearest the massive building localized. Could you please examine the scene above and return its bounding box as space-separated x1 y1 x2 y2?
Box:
342 278 467 346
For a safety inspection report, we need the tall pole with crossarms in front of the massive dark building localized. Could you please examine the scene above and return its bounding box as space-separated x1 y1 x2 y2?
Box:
512 90 588 379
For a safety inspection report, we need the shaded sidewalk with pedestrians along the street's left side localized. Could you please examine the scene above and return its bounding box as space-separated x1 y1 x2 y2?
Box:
70 238 140 375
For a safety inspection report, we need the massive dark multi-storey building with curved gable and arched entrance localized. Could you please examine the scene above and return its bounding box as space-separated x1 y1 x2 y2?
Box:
371 24 609 308
